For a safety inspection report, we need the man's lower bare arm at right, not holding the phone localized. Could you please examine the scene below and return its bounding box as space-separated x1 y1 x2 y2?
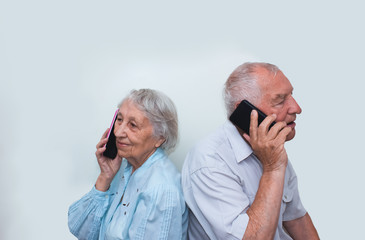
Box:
283 213 319 240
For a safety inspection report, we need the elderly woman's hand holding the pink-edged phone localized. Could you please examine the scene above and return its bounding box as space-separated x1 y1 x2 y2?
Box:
95 128 122 192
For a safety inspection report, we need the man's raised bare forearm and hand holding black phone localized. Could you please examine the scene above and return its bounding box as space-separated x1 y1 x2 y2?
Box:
243 111 291 240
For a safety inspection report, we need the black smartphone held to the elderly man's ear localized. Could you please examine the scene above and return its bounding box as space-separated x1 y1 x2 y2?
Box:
229 100 276 135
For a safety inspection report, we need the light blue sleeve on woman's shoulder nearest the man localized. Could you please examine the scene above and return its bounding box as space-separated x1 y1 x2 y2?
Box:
128 186 188 240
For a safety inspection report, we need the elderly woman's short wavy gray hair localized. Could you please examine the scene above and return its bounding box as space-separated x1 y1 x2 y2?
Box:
119 89 179 153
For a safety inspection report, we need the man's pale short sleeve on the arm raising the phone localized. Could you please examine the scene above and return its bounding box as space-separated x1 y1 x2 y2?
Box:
191 165 250 240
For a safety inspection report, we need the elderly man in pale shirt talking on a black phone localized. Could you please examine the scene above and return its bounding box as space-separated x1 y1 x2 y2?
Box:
182 63 319 240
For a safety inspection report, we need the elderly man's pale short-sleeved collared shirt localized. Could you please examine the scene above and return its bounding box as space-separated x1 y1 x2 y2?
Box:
182 121 306 240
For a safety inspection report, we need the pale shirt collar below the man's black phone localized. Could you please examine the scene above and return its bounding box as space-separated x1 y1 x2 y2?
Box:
224 120 253 163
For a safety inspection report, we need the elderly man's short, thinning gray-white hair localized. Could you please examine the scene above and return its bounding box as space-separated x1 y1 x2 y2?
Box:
223 62 280 117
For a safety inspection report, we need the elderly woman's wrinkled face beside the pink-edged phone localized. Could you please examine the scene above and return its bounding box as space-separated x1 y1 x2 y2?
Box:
114 100 164 165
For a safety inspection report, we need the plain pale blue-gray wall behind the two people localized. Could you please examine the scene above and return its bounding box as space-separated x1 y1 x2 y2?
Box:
0 0 365 240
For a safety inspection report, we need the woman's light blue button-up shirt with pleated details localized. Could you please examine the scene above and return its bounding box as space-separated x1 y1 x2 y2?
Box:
68 148 188 240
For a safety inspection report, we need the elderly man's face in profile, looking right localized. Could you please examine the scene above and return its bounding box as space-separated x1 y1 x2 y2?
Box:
257 69 302 141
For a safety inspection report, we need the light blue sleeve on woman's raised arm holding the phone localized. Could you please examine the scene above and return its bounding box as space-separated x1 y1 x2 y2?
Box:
68 186 112 240
